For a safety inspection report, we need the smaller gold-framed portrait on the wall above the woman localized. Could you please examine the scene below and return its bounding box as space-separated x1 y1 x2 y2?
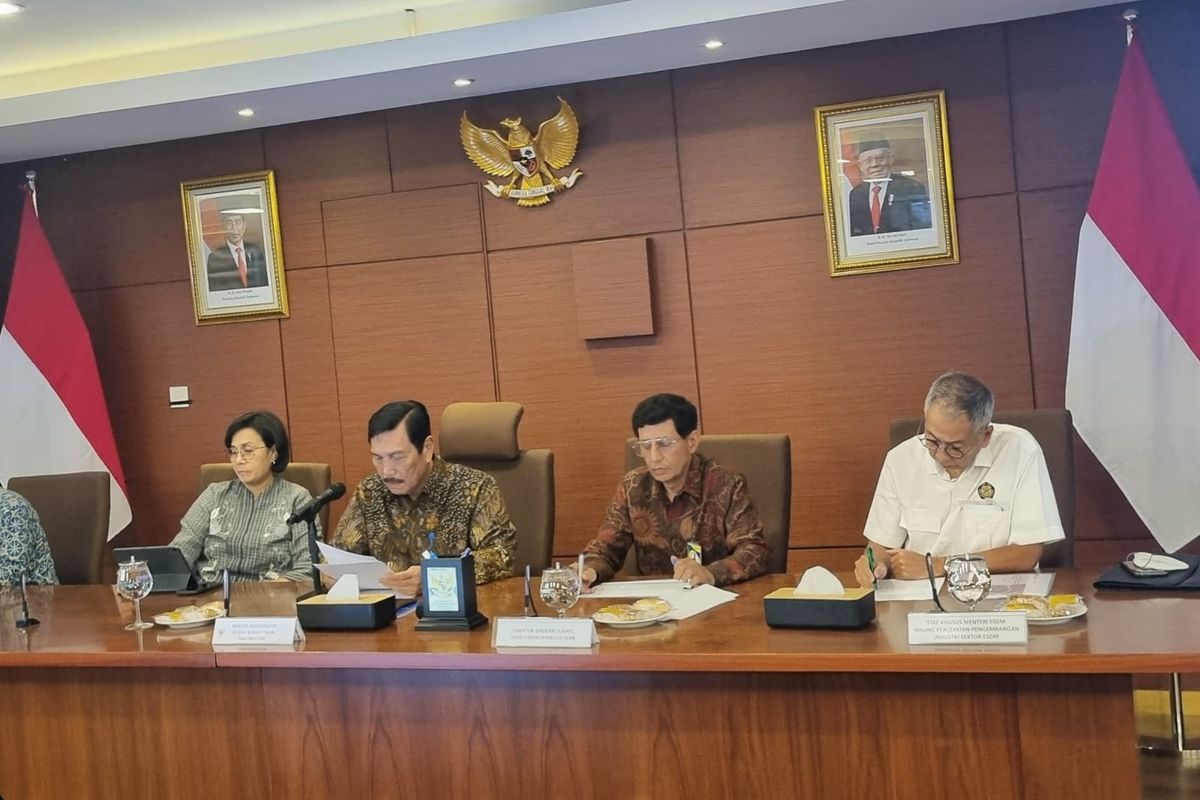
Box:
179 170 288 325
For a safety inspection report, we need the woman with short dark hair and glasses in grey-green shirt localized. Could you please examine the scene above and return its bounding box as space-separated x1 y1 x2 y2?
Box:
170 411 320 582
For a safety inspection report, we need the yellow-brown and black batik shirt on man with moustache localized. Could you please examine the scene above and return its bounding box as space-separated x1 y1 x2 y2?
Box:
331 457 517 583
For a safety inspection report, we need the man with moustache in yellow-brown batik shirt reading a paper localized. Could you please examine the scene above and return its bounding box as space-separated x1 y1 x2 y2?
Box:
330 401 516 595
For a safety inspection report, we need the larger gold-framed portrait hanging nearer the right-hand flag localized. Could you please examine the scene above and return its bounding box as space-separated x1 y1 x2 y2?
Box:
815 91 959 276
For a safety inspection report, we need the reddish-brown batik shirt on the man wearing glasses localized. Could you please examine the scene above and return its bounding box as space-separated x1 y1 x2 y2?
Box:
583 453 767 587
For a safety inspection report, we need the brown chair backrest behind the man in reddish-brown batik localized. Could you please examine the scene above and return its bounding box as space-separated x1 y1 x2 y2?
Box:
624 433 792 575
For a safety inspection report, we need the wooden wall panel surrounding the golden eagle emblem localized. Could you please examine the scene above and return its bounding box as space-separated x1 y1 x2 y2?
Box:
388 72 682 249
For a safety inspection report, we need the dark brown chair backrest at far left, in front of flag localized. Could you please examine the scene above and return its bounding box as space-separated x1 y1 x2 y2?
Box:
8 471 113 584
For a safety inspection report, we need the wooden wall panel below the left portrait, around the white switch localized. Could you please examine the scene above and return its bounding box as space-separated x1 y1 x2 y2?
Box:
77 282 288 545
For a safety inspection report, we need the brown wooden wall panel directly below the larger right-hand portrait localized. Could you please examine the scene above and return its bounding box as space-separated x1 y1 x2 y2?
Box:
688 196 1033 547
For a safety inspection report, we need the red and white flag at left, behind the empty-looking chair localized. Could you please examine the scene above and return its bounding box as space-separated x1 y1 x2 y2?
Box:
0 197 132 539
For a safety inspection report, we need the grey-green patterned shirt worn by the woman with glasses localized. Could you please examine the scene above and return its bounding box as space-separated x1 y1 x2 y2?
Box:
170 477 320 581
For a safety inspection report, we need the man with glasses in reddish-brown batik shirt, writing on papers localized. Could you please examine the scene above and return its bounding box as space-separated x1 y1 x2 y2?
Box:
582 395 767 587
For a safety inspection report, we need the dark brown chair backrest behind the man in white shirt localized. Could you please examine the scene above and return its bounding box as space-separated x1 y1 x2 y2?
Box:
890 408 1075 567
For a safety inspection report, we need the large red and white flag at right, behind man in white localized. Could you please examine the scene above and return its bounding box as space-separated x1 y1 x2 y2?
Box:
1067 37 1200 552
